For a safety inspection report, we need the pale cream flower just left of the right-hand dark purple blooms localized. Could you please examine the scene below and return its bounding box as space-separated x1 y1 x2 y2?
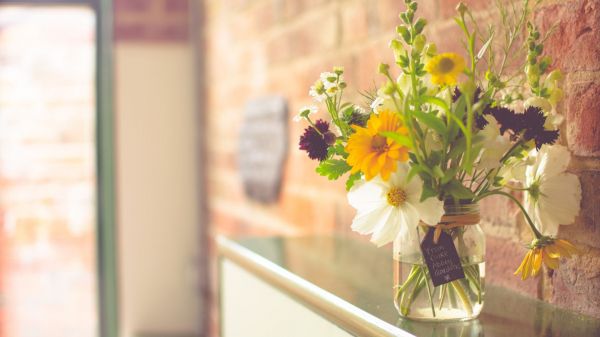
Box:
477 115 511 170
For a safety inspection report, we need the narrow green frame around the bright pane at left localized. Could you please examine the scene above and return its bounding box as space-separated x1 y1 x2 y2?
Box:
1 0 119 337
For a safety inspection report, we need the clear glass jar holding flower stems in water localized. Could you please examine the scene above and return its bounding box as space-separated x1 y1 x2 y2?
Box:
393 203 485 321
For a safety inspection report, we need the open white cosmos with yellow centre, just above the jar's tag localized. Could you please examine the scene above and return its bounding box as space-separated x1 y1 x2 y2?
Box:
348 163 444 246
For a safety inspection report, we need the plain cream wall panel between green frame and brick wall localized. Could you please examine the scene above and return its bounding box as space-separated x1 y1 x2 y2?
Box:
115 43 201 337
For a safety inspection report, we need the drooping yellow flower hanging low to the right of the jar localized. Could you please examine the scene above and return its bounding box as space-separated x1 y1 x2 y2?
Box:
515 237 579 280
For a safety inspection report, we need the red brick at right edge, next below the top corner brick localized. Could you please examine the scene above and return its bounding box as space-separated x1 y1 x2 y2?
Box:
565 82 600 157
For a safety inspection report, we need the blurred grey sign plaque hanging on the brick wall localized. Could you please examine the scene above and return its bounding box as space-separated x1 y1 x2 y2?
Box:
238 96 288 203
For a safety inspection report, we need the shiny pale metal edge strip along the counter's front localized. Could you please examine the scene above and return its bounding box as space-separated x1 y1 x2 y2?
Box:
216 235 414 337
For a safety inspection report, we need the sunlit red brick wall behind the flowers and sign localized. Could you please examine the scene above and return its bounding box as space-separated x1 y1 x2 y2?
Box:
204 0 600 328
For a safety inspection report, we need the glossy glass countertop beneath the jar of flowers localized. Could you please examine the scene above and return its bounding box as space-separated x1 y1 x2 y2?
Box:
218 235 600 337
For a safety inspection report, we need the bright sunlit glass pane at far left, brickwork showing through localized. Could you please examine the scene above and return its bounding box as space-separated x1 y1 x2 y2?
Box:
0 5 97 337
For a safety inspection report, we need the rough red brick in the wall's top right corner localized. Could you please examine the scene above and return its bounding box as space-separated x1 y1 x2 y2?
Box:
536 0 600 71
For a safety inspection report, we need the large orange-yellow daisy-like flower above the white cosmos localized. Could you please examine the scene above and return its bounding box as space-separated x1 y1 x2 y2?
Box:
346 110 408 180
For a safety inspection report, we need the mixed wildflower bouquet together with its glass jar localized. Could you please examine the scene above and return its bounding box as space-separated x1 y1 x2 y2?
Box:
295 0 581 319
